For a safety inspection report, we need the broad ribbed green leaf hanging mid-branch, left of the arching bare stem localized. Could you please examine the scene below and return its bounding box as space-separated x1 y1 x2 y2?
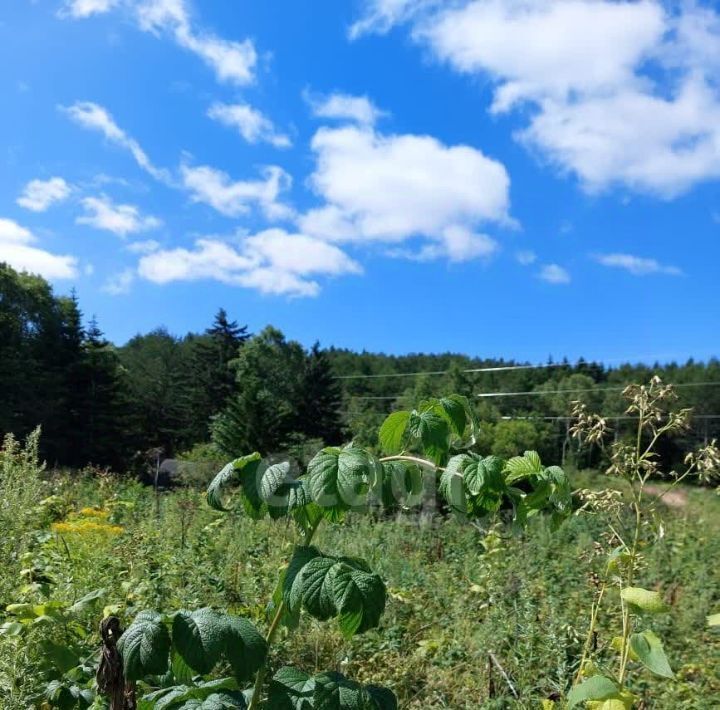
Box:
308 447 375 520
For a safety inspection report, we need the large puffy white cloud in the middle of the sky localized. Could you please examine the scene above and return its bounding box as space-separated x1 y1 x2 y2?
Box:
299 125 511 261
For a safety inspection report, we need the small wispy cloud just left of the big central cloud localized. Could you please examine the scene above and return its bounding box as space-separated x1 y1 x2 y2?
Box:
181 165 292 219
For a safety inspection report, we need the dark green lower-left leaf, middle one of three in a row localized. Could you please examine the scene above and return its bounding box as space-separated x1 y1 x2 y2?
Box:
172 608 227 675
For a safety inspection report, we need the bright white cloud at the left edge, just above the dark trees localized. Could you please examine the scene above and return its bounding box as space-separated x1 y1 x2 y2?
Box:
0 218 78 279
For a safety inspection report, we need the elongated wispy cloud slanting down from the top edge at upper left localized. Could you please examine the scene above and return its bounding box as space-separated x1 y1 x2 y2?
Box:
136 0 257 84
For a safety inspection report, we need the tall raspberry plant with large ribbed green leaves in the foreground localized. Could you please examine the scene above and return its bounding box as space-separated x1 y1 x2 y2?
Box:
111 395 571 710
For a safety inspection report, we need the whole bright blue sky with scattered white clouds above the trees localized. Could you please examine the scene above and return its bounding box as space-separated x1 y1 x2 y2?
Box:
0 0 720 361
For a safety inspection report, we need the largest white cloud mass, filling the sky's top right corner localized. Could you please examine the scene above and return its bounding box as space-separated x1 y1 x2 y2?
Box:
356 0 720 198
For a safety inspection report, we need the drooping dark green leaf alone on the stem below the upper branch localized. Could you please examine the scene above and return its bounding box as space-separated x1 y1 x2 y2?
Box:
283 547 386 637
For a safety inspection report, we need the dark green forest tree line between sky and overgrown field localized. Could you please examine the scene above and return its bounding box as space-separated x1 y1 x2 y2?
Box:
0 264 720 471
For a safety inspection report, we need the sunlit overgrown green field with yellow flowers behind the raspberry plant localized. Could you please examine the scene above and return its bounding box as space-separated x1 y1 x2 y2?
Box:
0 442 720 710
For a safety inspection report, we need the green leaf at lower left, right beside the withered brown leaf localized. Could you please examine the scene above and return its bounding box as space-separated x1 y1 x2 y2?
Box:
117 611 170 680
